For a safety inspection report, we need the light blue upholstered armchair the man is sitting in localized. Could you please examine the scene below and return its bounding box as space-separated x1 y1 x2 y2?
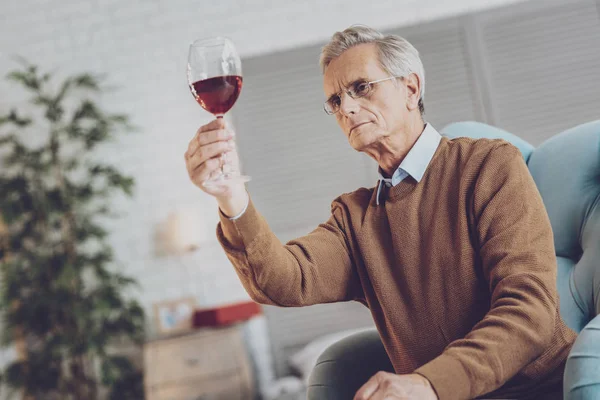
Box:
308 120 600 400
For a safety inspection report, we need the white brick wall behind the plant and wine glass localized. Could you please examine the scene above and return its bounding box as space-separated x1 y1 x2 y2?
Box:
0 0 523 396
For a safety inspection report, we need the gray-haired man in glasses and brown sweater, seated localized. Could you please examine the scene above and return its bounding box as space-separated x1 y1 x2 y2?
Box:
185 26 575 400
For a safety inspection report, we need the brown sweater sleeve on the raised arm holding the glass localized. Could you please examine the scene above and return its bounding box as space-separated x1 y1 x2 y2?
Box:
217 196 363 307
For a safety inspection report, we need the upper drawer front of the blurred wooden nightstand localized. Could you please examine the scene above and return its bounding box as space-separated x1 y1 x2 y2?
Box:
144 327 248 386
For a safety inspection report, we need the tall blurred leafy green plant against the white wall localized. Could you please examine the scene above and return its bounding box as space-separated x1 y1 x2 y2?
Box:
0 62 144 400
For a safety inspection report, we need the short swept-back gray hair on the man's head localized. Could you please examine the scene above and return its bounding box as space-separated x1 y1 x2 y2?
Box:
319 25 425 114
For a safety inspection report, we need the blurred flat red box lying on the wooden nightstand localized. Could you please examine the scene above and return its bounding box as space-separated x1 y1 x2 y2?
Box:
192 301 262 328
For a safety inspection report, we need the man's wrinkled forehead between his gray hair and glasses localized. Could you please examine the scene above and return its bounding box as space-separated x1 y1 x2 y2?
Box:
323 44 386 98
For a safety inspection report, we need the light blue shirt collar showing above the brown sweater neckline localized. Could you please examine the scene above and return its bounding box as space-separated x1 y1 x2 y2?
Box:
375 124 442 205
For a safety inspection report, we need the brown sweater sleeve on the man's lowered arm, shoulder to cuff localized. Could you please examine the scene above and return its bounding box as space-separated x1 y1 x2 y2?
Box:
415 143 558 400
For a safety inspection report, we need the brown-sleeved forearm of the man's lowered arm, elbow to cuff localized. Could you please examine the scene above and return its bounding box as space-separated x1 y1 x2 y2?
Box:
415 277 558 400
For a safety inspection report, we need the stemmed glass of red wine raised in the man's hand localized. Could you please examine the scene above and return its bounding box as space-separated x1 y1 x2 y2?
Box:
187 37 250 186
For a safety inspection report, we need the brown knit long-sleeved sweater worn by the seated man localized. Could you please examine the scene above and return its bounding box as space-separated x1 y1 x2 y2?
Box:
217 138 576 400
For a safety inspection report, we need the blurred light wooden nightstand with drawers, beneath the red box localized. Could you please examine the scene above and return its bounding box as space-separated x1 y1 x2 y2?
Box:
144 325 255 400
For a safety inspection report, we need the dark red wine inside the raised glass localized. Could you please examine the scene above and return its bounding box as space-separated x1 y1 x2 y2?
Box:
190 75 242 115
